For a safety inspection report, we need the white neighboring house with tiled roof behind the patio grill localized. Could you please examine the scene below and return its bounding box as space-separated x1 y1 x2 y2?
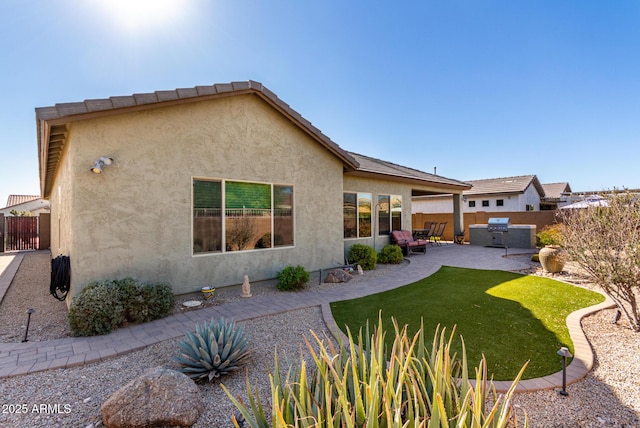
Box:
412 175 544 214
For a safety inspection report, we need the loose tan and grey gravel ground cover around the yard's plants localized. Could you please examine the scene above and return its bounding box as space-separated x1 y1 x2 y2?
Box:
0 251 640 427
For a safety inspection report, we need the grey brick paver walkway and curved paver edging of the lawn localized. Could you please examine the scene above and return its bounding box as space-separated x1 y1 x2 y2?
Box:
0 245 611 391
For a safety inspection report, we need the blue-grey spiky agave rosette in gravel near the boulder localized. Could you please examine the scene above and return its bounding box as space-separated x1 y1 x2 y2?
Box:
174 318 250 382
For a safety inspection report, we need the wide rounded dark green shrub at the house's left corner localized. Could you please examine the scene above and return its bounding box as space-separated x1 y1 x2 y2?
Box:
68 278 173 336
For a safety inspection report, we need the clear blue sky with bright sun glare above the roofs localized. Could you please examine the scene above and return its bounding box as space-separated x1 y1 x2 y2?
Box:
0 0 640 206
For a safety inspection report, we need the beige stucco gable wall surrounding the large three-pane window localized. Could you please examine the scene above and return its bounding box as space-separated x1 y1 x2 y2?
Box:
51 95 343 296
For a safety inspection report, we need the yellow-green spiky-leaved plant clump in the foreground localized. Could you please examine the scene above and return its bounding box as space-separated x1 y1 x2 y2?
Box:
222 318 527 428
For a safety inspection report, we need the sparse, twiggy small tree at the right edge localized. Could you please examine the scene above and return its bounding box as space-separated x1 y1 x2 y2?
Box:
560 191 640 331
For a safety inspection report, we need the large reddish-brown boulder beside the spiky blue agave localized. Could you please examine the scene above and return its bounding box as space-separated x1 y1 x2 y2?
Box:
101 367 203 428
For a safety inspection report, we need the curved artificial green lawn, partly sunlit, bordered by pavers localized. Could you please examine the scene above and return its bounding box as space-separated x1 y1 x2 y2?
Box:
331 266 604 380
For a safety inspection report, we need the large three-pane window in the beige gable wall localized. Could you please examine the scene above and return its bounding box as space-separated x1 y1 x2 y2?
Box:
193 179 293 253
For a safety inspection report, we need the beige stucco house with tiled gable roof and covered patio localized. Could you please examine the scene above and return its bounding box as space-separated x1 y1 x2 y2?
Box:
36 81 470 297
